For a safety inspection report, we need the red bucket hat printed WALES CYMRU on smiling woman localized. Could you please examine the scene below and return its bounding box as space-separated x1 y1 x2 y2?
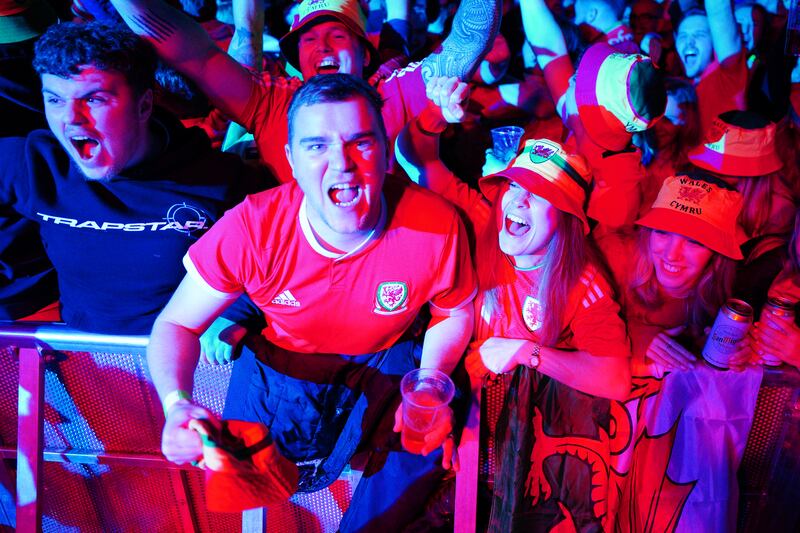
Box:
636 175 746 259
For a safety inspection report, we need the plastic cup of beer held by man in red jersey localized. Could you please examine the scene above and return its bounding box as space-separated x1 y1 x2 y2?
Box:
400 368 456 454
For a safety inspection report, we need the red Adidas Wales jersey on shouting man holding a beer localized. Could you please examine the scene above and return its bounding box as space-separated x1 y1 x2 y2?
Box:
184 176 475 355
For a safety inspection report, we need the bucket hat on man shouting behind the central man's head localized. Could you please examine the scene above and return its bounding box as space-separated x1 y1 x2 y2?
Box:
280 0 380 74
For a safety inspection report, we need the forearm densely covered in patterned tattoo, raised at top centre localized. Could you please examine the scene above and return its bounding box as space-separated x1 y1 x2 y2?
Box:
422 0 502 83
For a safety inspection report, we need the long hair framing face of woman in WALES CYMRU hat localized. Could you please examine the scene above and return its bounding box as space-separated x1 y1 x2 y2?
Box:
628 227 735 337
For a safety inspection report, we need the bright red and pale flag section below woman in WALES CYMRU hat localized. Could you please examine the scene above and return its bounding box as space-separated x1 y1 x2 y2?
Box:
609 361 762 533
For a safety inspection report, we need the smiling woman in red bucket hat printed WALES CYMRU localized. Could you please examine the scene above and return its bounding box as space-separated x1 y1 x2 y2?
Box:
598 174 748 376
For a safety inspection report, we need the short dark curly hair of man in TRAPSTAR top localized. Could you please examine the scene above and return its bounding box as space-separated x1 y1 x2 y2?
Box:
33 22 157 94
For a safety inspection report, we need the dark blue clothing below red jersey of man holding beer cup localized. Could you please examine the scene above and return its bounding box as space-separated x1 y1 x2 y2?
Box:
224 339 444 533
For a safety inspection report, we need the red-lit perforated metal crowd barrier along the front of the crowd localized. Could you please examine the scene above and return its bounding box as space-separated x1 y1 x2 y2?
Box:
6 322 800 533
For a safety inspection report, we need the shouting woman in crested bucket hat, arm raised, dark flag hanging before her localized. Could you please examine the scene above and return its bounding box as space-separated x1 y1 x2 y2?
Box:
397 97 630 531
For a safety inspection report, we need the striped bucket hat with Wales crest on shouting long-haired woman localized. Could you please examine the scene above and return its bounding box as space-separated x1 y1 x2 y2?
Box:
478 139 592 235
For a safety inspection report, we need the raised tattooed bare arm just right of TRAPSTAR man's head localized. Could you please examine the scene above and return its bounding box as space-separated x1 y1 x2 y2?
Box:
111 0 254 120
